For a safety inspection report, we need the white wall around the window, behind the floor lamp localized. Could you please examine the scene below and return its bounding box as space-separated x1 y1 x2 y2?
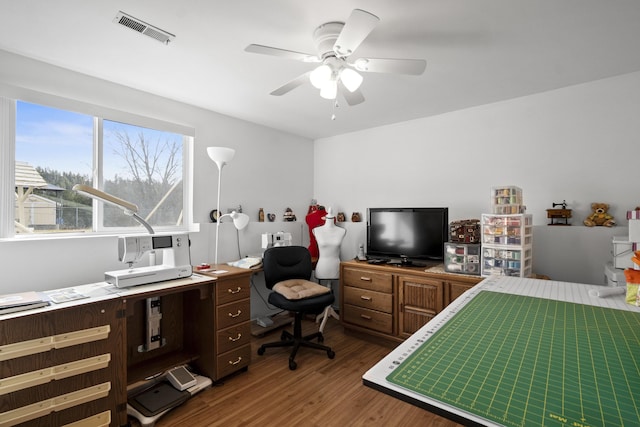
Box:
0 51 313 294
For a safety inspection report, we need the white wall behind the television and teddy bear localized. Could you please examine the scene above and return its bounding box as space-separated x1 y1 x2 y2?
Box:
314 73 640 283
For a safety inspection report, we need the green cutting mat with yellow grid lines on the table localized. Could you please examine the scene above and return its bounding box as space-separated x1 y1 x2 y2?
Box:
387 291 640 427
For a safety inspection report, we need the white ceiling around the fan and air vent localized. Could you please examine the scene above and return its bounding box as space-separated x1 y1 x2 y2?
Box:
0 0 640 139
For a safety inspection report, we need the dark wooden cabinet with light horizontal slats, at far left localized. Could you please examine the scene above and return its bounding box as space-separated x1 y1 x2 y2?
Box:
0 298 127 426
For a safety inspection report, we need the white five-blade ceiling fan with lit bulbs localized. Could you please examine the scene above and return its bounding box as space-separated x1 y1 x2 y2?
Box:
245 9 427 105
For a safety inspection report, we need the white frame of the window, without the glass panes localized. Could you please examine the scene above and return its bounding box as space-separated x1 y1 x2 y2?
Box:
0 90 198 240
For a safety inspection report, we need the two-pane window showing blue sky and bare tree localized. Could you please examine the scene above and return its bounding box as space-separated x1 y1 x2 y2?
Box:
0 101 192 237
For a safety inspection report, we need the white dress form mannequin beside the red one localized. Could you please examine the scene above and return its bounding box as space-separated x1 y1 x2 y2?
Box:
313 208 347 332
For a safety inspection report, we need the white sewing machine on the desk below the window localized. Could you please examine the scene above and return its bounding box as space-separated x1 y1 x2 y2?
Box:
104 233 192 288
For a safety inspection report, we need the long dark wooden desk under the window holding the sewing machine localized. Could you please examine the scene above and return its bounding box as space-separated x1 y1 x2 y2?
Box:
0 266 251 427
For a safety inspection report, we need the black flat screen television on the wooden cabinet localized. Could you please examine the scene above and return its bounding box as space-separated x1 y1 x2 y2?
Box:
367 208 449 264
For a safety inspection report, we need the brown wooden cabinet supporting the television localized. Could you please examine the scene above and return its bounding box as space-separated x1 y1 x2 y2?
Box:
340 260 482 341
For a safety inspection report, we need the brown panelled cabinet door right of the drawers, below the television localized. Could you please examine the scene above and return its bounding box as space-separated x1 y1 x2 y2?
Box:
398 275 444 338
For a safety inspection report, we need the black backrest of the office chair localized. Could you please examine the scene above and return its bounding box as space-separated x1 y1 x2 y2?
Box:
262 246 313 289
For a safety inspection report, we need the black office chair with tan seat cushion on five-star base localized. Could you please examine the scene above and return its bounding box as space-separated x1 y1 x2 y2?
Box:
258 246 335 371
